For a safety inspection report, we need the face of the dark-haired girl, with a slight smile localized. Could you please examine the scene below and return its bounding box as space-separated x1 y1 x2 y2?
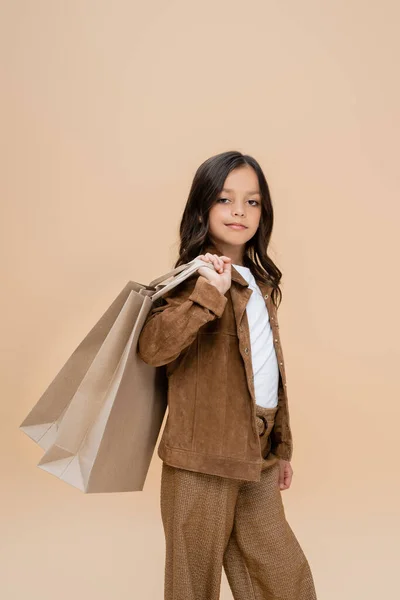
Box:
209 165 261 247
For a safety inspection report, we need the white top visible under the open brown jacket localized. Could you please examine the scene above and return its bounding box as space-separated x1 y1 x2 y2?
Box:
233 264 279 407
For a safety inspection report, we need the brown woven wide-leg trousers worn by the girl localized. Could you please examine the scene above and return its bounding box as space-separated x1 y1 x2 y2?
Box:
160 405 316 600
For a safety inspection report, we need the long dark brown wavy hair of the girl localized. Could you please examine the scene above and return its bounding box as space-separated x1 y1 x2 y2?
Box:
174 150 282 307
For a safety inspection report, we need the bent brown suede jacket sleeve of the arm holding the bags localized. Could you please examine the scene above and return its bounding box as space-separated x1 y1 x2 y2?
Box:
138 274 228 367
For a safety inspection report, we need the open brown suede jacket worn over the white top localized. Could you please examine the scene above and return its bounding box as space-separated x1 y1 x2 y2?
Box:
138 245 293 481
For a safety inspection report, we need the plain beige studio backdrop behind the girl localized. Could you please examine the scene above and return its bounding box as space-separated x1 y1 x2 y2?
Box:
0 0 400 600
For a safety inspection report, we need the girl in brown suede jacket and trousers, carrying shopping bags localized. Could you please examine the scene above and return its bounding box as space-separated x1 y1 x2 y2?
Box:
138 152 316 600
